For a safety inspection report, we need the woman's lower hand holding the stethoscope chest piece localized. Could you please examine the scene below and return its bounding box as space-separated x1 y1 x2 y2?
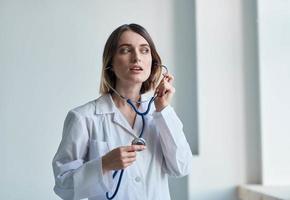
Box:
102 145 146 173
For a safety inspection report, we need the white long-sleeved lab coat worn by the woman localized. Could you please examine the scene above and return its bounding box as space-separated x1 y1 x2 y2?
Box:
52 94 192 200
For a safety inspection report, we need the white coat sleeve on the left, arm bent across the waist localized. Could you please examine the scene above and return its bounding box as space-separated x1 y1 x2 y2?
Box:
52 111 112 200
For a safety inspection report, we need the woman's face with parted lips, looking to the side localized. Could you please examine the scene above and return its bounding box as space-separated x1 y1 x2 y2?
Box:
112 31 152 85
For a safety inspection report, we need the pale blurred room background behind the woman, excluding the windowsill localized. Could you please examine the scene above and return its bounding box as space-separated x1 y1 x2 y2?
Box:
0 0 290 200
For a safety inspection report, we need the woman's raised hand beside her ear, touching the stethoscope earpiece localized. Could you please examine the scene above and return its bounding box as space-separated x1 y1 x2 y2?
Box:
154 74 175 112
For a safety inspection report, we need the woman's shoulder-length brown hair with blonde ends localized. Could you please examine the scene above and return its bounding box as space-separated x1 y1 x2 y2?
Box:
100 24 162 95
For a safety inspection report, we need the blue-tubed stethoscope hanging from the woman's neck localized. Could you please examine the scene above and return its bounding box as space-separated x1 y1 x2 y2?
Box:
106 65 168 200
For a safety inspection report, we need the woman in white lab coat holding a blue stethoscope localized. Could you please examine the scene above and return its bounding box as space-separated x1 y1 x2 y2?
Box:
53 24 192 200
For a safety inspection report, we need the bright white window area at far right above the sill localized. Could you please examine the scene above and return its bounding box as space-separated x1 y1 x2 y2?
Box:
258 0 290 185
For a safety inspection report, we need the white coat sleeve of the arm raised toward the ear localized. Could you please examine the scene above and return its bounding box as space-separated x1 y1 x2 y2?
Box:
153 106 193 177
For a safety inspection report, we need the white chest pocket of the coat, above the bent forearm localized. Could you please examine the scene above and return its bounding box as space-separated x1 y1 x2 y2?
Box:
89 139 109 159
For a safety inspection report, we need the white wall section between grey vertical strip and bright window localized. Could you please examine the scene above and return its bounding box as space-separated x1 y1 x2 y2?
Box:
189 0 260 200
